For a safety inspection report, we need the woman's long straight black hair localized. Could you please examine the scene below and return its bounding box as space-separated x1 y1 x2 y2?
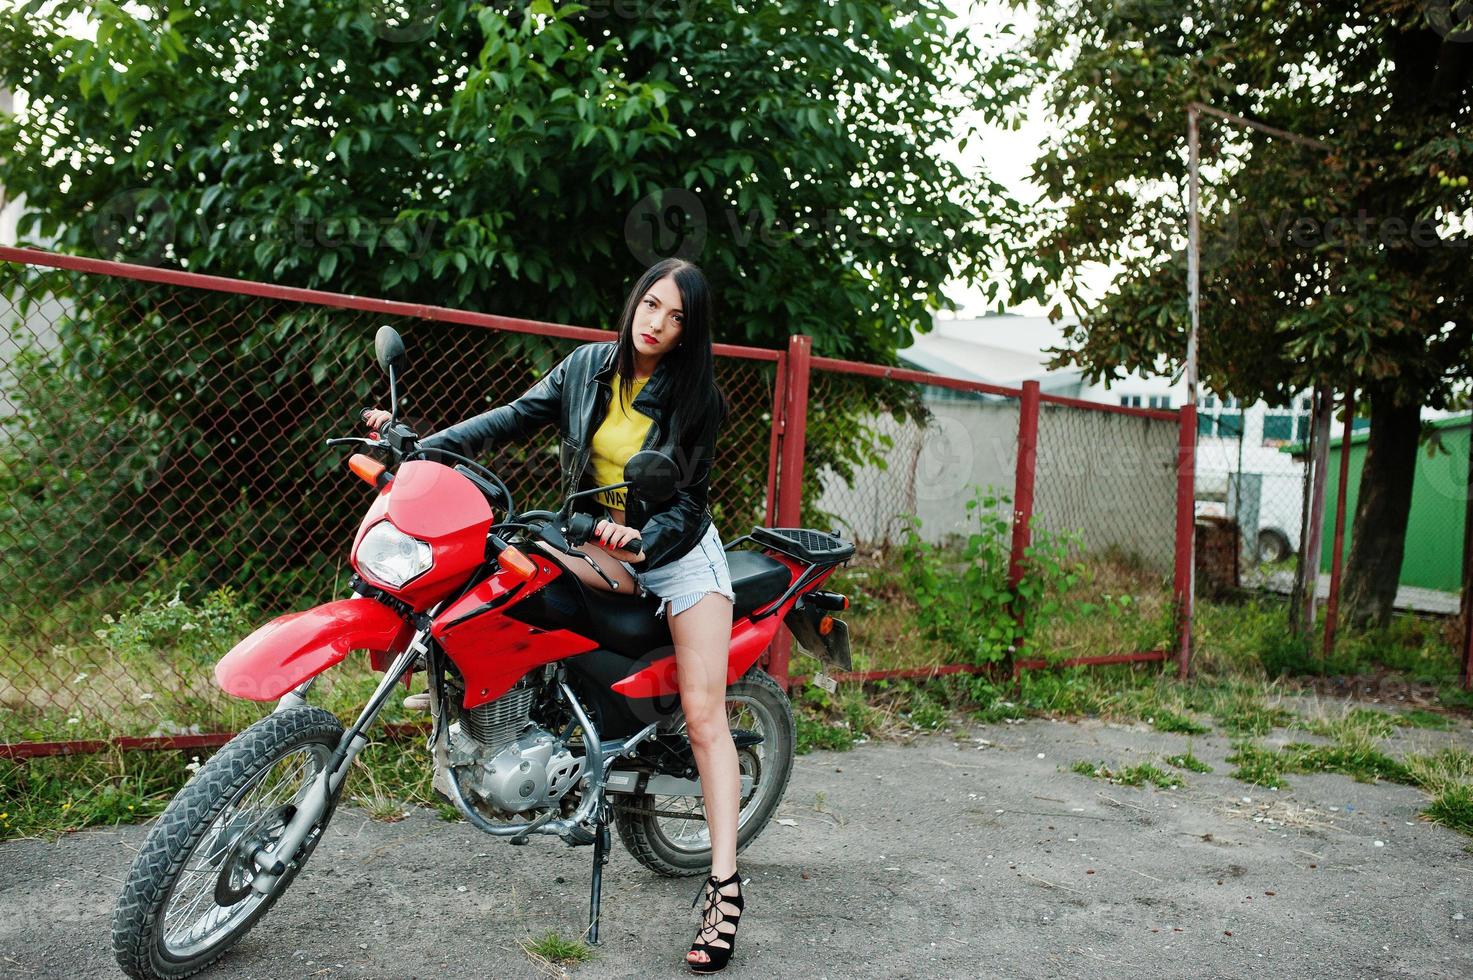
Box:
614 258 729 445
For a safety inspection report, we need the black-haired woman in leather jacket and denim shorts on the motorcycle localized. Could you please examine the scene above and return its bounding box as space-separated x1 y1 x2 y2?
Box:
365 259 744 973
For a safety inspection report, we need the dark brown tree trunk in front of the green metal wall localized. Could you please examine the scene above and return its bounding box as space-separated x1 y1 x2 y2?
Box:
1342 389 1421 628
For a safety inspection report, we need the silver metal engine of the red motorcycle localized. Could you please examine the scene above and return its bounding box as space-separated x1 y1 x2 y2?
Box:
449 685 583 813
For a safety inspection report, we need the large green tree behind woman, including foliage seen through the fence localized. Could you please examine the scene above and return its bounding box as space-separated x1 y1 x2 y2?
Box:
0 0 1013 588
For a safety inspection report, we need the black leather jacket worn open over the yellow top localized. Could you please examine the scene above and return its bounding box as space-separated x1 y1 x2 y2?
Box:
420 340 716 570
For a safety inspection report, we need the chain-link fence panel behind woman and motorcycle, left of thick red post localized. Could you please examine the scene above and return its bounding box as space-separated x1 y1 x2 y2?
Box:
0 252 779 743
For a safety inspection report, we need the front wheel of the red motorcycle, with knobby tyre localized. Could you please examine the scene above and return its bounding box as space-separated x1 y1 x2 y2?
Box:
112 706 343 980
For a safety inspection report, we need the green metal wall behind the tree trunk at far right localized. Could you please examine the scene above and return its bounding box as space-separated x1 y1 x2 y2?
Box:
1321 416 1473 592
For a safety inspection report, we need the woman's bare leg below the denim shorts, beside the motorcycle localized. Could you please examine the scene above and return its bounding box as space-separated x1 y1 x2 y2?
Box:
670 592 741 962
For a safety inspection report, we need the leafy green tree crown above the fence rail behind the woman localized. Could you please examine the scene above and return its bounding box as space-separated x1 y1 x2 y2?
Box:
0 0 1009 363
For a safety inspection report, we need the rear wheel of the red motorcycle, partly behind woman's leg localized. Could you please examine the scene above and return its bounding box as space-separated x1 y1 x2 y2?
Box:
614 668 797 878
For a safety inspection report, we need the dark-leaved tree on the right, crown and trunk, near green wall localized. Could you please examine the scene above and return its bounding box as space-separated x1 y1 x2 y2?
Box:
1013 0 1473 623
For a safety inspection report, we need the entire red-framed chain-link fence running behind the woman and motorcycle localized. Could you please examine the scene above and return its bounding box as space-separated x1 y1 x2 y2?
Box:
0 246 1207 744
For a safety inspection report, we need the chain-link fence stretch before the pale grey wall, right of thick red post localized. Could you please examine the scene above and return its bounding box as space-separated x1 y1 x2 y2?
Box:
803 358 1180 680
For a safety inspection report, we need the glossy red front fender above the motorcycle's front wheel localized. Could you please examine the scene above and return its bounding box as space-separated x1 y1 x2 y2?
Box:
215 598 414 701
